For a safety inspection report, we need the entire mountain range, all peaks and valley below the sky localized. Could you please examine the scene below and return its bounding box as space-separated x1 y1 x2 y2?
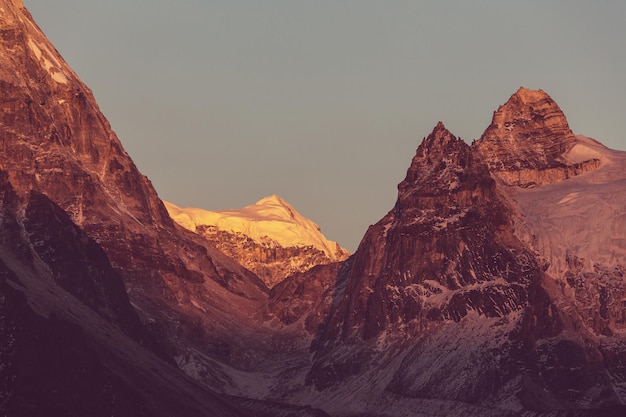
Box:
0 0 626 417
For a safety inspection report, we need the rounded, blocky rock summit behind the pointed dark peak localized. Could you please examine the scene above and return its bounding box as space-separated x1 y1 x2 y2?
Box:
474 87 600 187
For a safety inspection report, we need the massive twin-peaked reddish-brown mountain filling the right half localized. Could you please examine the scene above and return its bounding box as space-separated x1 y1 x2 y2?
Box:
288 88 626 416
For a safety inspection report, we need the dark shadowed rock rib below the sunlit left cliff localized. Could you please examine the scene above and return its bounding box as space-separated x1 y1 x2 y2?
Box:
0 171 141 338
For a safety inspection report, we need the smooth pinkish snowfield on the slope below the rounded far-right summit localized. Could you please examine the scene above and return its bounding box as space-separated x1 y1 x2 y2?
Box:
514 136 626 277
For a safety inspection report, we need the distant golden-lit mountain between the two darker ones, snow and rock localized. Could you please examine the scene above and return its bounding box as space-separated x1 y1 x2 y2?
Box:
165 195 350 288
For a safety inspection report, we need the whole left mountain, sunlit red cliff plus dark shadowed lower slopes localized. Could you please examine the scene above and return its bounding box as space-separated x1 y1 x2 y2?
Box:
0 0 323 416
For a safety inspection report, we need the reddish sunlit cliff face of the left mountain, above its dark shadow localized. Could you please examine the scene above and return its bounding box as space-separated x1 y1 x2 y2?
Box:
0 0 268 374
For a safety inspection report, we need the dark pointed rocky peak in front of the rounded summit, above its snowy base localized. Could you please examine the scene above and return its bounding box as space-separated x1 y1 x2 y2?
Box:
314 123 540 339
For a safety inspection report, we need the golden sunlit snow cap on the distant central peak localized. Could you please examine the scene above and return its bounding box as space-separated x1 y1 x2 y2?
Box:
164 195 347 260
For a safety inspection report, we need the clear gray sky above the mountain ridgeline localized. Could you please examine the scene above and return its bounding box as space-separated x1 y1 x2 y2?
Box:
24 0 626 251
